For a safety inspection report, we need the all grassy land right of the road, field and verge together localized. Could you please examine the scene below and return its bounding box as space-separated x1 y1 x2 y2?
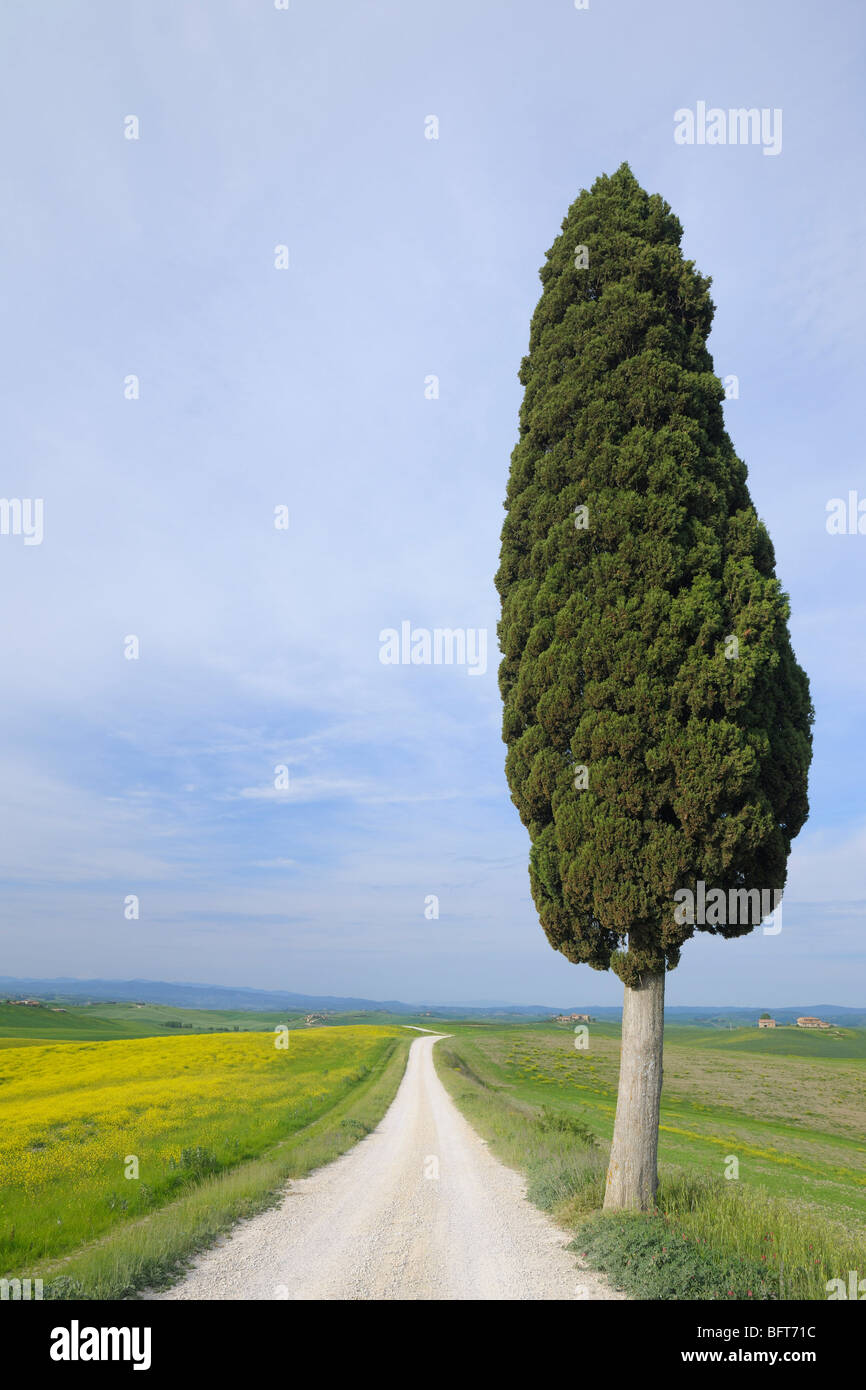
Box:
434 1023 866 1298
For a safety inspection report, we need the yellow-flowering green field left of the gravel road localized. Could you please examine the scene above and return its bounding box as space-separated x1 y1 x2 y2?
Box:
0 1026 399 1272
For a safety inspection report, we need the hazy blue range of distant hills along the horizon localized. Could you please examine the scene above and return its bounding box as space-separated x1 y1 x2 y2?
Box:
0 976 866 1029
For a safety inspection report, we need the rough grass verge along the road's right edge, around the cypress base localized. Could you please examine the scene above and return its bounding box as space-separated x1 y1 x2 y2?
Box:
434 1038 863 1301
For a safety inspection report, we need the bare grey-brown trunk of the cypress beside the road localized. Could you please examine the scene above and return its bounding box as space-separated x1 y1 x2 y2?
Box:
605 974 664 1211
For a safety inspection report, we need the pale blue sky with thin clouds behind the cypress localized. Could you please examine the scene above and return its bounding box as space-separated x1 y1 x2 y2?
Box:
0 0 866 1006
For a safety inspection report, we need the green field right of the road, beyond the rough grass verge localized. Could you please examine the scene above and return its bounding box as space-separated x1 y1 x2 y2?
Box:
439 1023 866 1222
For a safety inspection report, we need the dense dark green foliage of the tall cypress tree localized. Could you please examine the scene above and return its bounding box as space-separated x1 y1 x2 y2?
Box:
496 164 812 984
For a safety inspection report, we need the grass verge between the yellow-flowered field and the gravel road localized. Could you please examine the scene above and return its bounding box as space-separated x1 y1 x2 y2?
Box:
35 1038 410 1300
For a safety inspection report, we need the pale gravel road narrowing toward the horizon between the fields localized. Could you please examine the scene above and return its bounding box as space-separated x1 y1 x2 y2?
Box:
154 1036 620 1300
